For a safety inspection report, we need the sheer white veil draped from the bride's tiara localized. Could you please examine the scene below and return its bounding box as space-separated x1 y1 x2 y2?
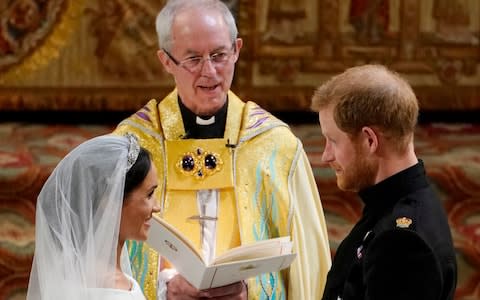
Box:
27 135 138 300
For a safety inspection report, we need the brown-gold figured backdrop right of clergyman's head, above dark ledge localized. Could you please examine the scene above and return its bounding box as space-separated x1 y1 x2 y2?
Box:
237 0 480 110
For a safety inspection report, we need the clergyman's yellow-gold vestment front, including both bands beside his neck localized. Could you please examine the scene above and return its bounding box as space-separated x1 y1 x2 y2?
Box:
159 93 244 262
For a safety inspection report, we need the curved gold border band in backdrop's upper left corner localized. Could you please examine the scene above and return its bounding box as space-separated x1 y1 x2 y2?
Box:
0 0 85 84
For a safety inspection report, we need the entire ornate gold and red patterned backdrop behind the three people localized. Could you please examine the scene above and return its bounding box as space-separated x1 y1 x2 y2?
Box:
0 0 480 300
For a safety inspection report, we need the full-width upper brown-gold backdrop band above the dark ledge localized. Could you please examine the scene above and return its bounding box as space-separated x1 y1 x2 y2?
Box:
0 0 480 111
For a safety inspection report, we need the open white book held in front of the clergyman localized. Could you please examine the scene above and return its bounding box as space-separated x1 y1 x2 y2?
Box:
147 215 296 289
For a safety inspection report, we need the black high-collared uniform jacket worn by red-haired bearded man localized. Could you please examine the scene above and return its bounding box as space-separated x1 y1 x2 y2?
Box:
323 161 457 300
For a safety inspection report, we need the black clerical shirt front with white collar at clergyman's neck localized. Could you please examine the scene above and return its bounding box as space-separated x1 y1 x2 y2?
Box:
178 97 228 139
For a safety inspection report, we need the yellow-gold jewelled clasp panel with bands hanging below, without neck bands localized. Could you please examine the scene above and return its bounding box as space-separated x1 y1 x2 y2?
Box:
162 139 240 260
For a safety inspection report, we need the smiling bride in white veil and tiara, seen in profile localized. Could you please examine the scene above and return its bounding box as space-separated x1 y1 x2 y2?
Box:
27 134 159 300
